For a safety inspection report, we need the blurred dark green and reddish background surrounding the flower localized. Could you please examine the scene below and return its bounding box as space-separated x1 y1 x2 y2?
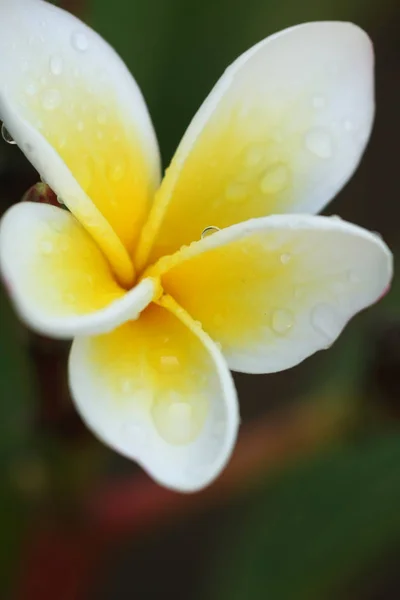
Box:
0 0 400 600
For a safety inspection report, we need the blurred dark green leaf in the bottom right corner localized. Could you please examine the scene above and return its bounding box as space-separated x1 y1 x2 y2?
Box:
211 432 400 600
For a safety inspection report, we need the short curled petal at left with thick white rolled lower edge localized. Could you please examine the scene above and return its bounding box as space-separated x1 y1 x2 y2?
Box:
0 202 156 338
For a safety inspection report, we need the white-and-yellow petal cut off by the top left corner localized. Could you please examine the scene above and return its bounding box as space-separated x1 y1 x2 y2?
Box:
0 0 160 280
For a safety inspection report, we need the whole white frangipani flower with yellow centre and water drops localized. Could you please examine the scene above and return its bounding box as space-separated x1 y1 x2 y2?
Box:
0 0 392 491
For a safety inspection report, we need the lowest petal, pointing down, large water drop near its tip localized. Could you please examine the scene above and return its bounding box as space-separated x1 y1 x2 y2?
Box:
70 299 239 492
